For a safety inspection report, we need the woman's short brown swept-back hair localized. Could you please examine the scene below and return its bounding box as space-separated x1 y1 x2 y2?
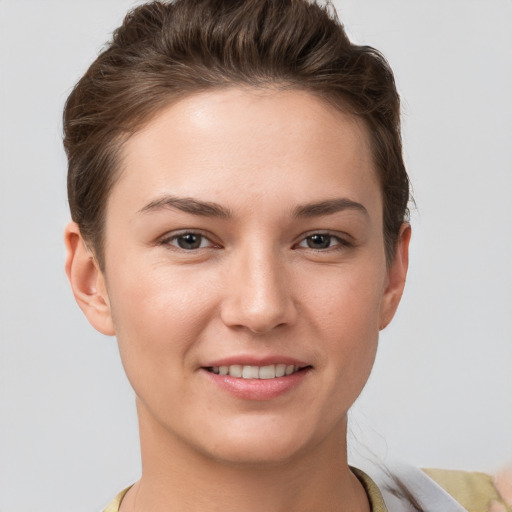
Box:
64 0 409 267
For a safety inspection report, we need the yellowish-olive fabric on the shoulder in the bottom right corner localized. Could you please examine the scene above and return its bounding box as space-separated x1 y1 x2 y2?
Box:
423 469 502 512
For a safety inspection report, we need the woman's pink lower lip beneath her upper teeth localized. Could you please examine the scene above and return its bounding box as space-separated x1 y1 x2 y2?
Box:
202 368 310 401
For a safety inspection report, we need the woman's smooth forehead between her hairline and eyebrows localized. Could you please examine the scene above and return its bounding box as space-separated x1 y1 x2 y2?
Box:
109 88 380 218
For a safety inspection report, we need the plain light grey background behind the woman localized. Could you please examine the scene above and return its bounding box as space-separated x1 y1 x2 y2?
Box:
0 0 512 512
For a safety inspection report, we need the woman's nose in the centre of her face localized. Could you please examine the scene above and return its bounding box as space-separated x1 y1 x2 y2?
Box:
221 246 297 334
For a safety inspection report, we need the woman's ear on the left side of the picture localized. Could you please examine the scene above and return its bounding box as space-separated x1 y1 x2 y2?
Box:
64 222 115 336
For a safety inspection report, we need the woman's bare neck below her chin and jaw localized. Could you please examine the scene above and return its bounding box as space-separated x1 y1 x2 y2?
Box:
121 404 370 512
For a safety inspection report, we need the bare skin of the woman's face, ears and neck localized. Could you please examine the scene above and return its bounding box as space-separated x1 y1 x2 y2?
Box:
66 88 410 512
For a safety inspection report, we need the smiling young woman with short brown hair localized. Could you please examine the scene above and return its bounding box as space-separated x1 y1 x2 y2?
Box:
64 0 508 512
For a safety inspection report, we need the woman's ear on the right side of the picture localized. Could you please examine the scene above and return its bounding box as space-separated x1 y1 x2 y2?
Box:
379 222 411 330
